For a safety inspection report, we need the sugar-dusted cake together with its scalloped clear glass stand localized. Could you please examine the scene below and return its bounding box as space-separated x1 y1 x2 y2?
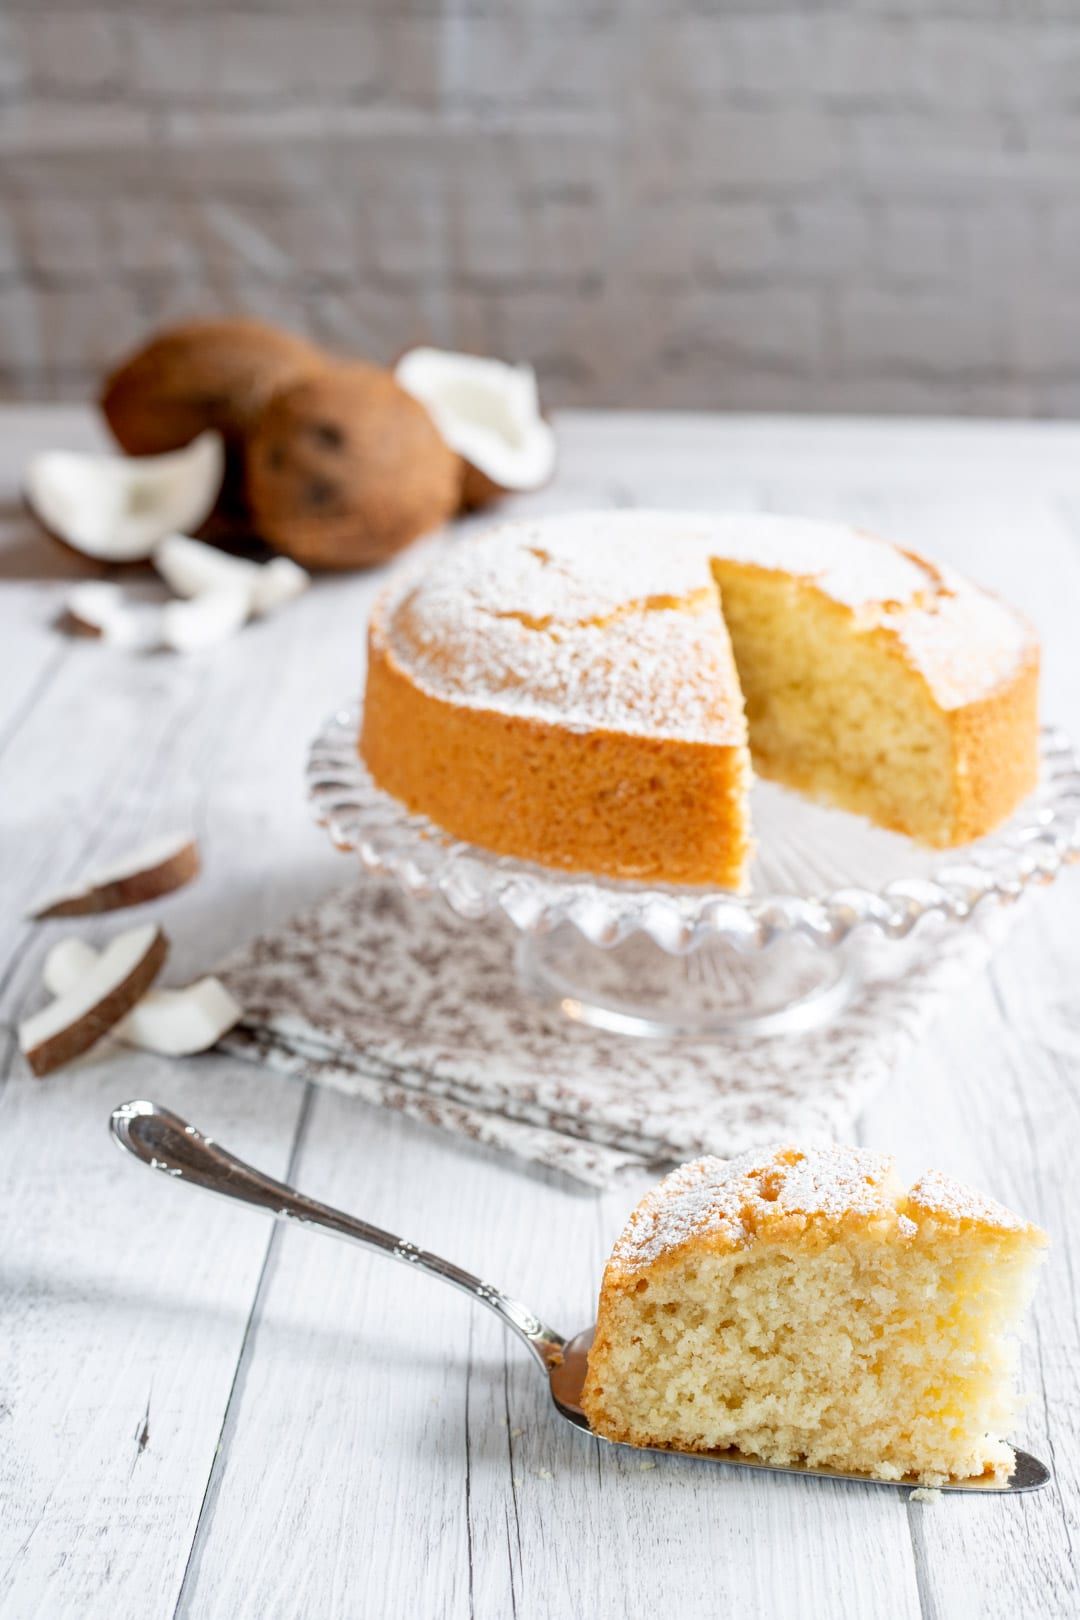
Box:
309 510 1080 1035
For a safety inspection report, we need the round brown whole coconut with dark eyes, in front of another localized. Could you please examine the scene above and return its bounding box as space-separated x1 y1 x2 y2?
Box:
246 361 463 569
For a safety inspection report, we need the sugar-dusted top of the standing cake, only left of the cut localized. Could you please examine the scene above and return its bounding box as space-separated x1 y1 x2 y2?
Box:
376 512 746 745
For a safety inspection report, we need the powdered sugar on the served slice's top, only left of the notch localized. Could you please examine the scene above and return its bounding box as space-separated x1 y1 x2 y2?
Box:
612 1147 904 1272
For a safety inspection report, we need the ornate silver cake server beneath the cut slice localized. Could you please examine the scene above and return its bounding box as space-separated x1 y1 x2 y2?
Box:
108 1102 1051 1492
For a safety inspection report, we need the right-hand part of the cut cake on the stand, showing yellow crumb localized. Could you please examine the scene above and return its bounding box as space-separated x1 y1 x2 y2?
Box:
711 514 1040 847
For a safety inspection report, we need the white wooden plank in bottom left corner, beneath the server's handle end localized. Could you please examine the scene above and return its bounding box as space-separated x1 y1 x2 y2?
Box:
0 1053 307 1620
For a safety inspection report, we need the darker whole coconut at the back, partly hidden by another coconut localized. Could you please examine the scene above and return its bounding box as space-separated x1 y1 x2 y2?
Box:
100 319 327 455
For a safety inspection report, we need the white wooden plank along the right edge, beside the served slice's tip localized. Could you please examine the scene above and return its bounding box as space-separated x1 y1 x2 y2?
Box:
860 913 1080 1617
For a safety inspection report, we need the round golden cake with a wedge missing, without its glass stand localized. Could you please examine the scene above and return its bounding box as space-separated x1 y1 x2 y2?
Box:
359 512 1040 888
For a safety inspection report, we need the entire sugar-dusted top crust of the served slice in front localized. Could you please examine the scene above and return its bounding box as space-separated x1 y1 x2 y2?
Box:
612 1147 1033 1275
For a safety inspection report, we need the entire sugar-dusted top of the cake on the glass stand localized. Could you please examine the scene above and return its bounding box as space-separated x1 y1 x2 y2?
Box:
376 510 1035 732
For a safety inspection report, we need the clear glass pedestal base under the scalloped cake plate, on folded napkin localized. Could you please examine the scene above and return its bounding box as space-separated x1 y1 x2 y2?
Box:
517 927 858 1040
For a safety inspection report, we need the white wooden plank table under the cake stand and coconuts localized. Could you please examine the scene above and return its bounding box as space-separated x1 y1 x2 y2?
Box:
0 408 1080 1620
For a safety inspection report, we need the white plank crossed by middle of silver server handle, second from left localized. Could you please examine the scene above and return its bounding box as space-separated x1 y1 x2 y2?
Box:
176 1094 488 1620
